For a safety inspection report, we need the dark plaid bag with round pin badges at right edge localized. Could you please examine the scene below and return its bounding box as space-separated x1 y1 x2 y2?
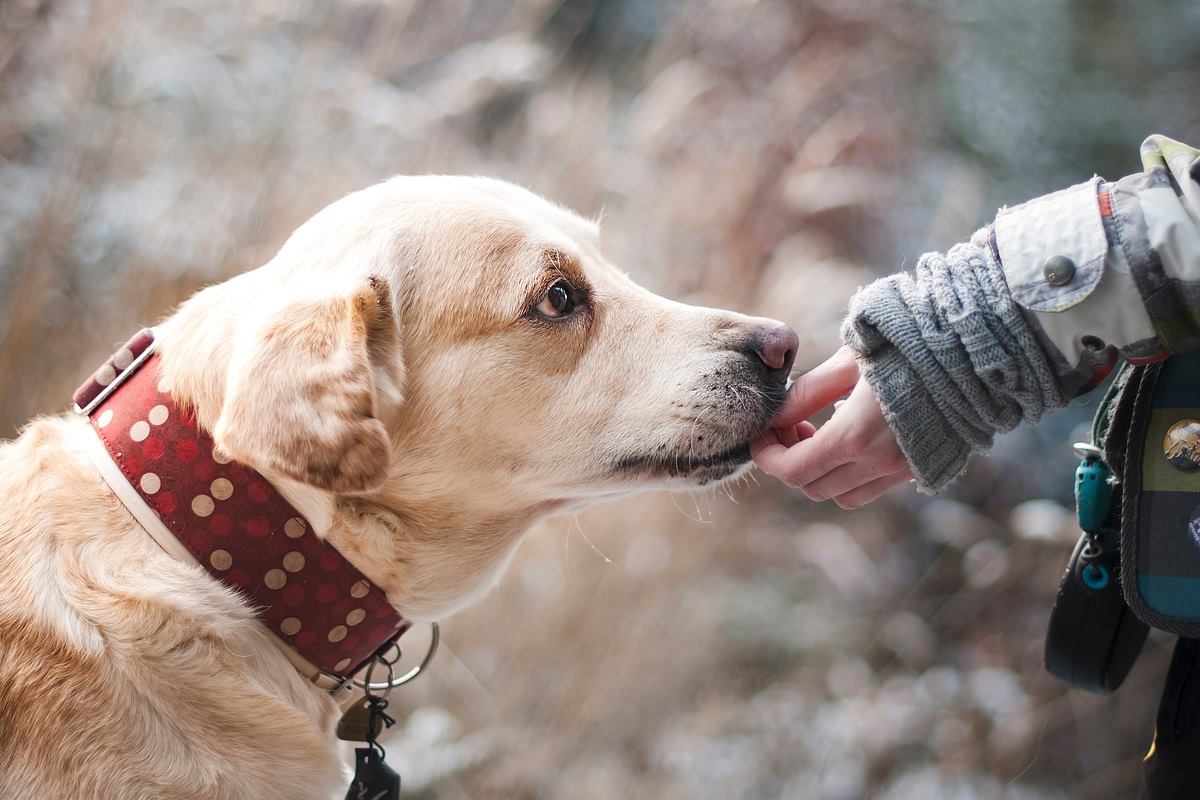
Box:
1098 350 1200 638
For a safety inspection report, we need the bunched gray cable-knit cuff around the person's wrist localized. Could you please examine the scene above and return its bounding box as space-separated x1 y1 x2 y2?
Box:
841 229 1068 493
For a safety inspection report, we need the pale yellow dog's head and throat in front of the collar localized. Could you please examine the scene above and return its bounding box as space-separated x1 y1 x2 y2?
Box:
163 176 797 618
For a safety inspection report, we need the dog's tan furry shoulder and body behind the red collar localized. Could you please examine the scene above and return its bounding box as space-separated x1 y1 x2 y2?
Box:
0 417 341 798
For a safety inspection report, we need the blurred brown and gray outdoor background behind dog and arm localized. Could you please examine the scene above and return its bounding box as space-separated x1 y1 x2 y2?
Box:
0 0 1200 800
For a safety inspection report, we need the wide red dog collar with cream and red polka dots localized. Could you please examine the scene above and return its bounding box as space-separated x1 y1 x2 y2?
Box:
74 330 409 680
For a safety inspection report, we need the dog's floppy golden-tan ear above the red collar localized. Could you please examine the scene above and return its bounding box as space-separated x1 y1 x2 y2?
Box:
212 278 403 492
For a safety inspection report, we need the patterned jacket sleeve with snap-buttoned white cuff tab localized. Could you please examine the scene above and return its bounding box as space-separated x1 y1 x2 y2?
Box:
990 136 1200 396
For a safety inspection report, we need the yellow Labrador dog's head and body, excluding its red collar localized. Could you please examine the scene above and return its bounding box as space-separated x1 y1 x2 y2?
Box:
0 176 797 800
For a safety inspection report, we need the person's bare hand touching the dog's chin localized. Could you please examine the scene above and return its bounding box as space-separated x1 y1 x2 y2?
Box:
750 347 912 509
